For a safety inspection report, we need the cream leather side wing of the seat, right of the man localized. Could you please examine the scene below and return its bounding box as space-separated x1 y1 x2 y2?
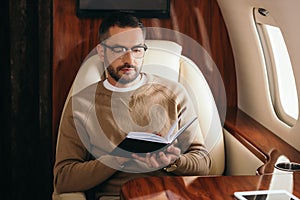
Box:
179 56 225 175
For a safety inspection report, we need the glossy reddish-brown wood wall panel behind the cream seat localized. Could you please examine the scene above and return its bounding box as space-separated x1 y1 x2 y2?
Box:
52 0 237 147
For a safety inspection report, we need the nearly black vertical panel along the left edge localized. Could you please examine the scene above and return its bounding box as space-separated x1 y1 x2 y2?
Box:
0 0 53 200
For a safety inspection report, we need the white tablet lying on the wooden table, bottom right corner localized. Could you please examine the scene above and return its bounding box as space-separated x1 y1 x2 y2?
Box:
234 190 299 200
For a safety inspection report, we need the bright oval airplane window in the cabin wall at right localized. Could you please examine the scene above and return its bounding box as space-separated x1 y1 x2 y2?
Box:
256 9 299 126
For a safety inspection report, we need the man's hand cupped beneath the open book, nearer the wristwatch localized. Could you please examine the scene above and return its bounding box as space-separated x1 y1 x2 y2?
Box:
132 145 181 168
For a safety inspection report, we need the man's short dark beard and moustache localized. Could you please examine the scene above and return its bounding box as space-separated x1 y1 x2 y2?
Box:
107 64 140 84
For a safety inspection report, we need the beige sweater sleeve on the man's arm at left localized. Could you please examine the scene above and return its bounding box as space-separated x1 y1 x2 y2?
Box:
54 99 117 193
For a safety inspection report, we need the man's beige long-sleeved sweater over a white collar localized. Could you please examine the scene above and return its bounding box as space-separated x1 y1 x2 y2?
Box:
54 74 210 198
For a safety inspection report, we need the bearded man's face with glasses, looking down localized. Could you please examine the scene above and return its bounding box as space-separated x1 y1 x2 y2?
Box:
103 26 145 87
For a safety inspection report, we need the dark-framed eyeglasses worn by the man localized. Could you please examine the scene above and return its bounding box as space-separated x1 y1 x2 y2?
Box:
101 43 148 58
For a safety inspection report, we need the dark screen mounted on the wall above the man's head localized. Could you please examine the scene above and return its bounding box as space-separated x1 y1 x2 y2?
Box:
76 0 170 18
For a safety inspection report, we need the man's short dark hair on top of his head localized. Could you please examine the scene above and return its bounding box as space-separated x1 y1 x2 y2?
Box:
99 12 144 42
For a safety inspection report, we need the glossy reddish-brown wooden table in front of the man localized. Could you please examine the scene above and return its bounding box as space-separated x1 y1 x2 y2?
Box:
120 172 300 200
